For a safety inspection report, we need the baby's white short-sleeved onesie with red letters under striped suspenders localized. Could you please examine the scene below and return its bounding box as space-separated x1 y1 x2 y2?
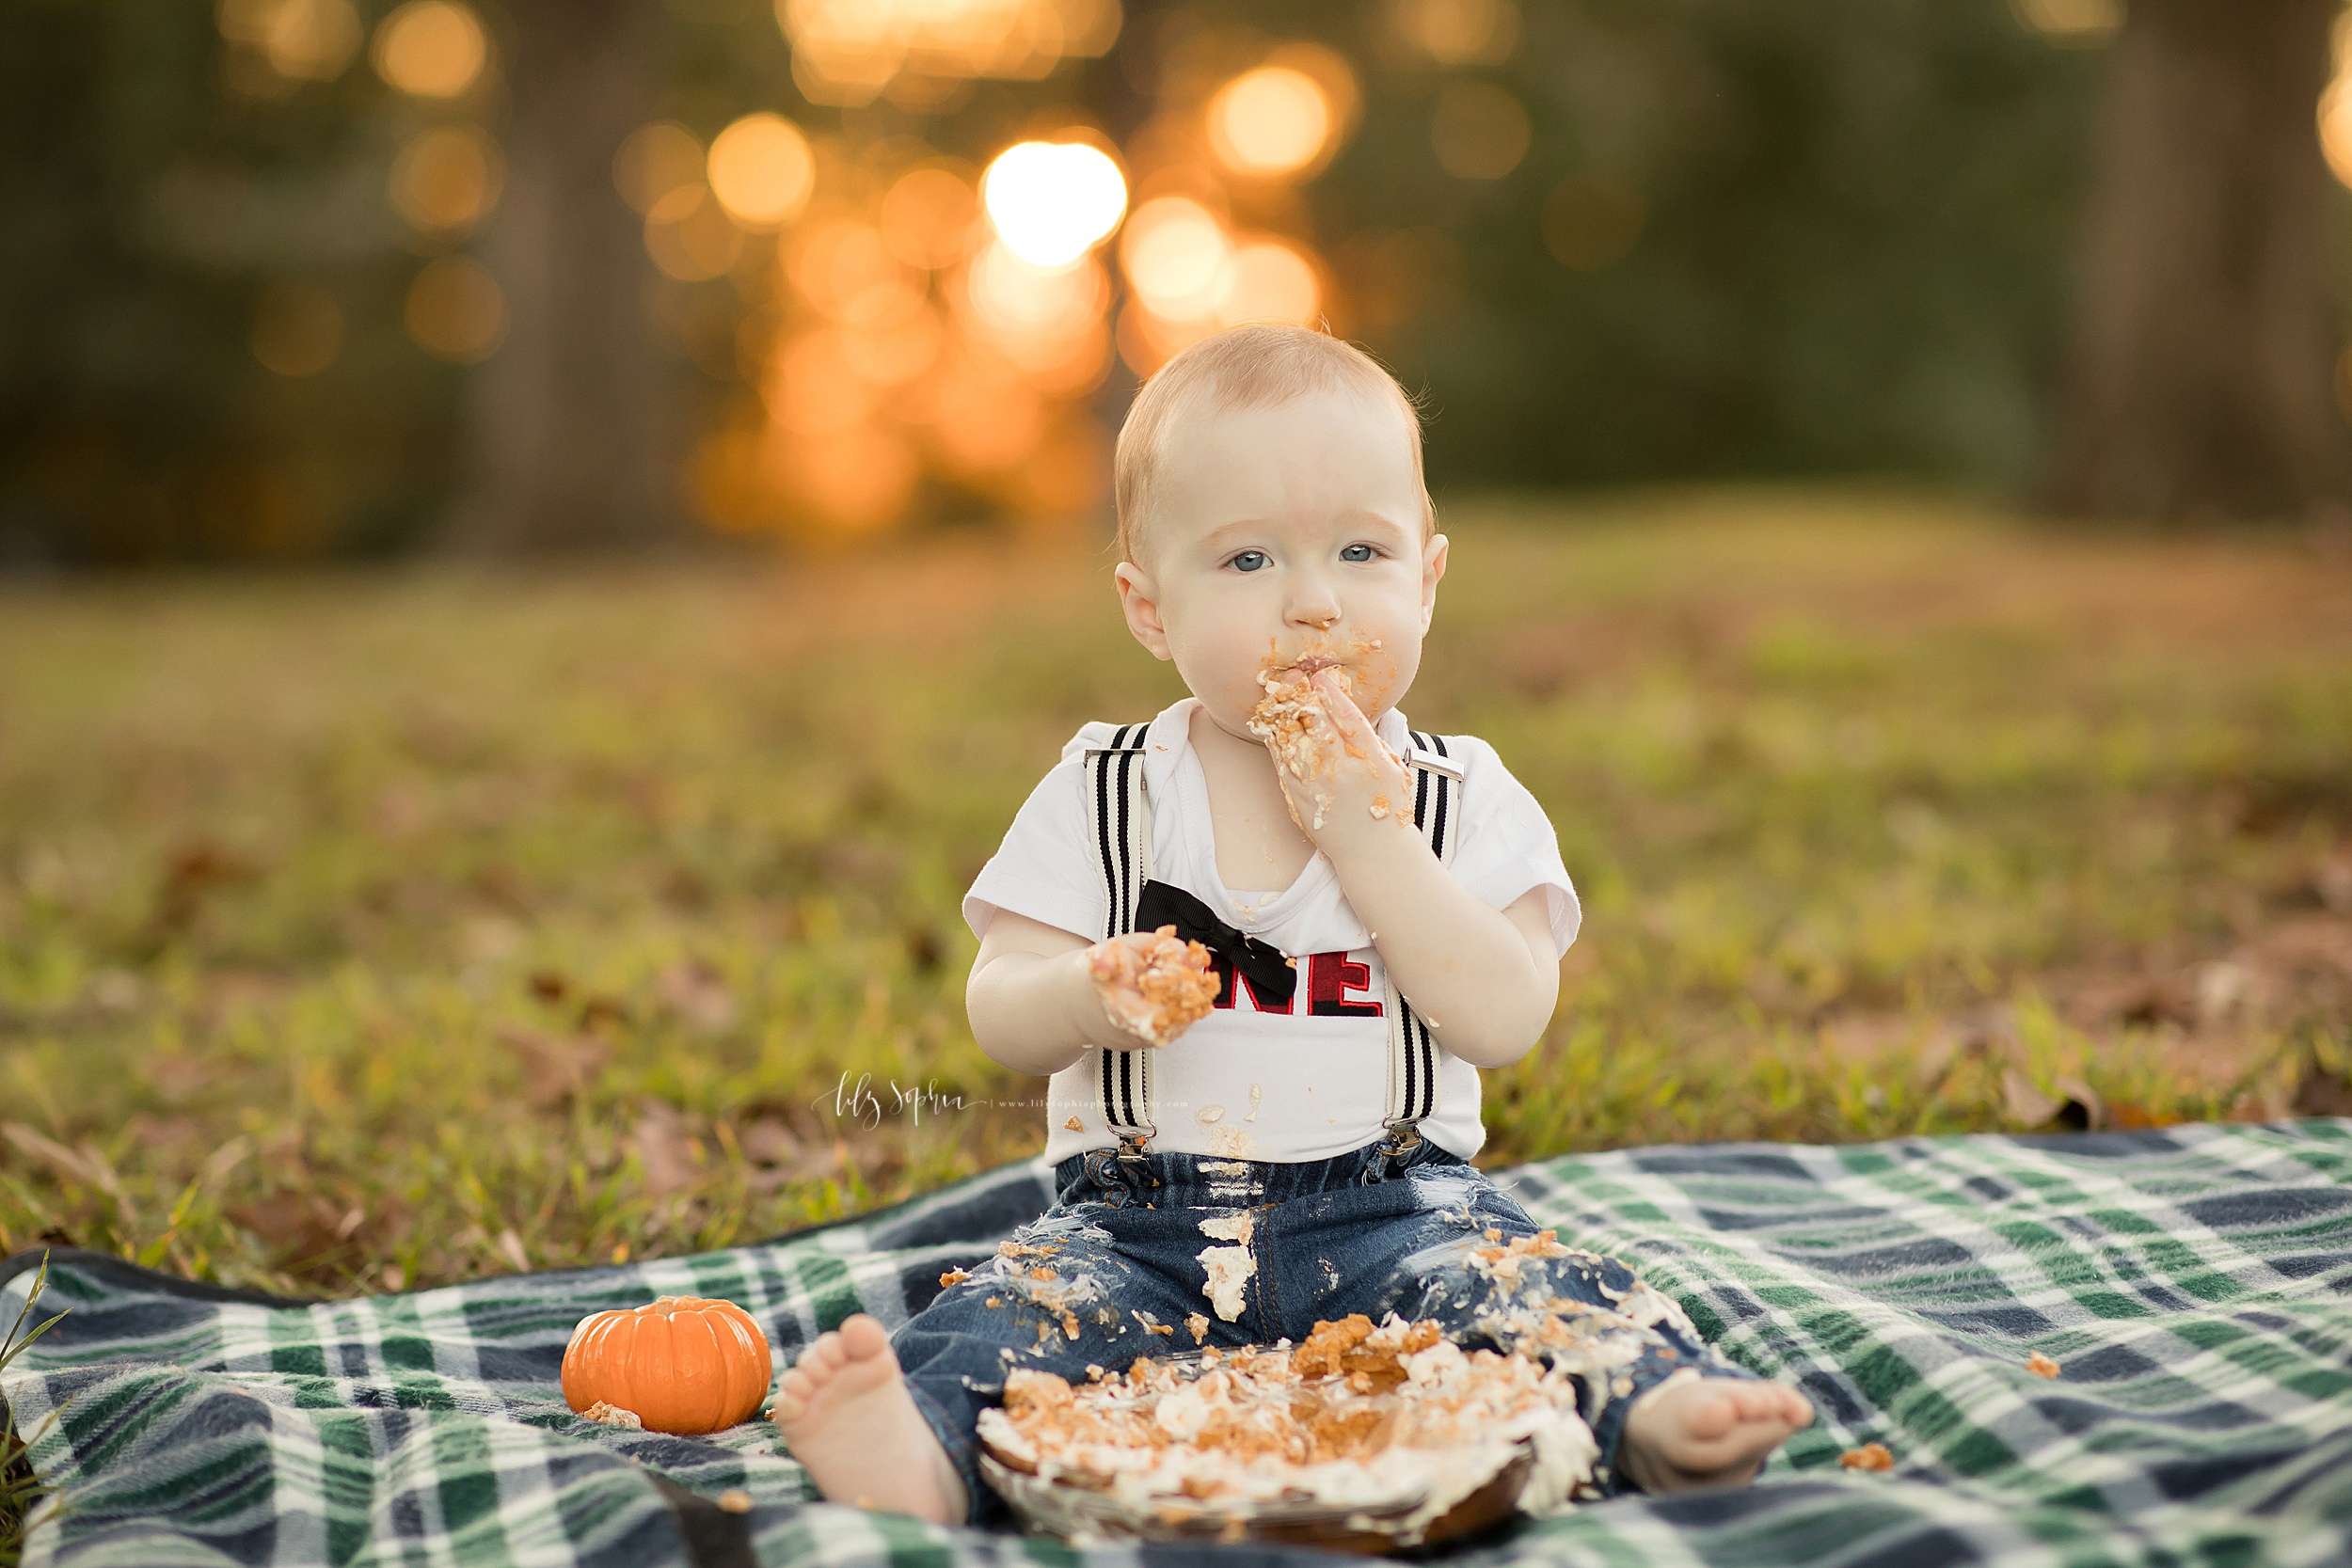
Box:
964 698 1579 1162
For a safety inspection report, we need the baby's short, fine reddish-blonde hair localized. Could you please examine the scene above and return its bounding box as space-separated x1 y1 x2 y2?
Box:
1113 325 1438 562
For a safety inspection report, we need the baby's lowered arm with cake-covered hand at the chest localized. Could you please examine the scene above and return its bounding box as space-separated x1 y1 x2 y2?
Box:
964 910 1216 1077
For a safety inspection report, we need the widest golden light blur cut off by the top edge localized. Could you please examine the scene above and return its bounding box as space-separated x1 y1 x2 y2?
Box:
776 0 1120 105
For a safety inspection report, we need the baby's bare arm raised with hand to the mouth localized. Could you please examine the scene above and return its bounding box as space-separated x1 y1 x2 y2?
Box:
1275 673 1560 1068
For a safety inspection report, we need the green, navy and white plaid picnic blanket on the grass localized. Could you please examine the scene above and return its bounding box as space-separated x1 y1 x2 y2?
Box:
0 1121 2352 1568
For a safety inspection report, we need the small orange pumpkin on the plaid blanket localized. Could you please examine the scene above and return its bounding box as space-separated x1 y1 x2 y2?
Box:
564 1295 776 1436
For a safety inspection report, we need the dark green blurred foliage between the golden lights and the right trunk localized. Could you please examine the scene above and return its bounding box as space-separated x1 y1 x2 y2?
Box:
1311 0 2101 489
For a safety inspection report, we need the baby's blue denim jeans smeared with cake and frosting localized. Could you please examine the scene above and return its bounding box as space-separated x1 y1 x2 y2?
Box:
892 1140 1750 1524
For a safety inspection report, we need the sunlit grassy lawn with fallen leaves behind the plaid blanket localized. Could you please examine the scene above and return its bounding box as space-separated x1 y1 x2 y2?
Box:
0 491 2352 1295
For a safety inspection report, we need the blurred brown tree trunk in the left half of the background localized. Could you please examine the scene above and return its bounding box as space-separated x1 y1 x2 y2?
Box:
452 0 677 550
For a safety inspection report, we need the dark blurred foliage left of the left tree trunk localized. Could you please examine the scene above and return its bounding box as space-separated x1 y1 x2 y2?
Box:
0 0 459 564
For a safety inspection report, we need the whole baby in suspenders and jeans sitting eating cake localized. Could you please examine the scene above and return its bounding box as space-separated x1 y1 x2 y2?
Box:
771 326 1814 1524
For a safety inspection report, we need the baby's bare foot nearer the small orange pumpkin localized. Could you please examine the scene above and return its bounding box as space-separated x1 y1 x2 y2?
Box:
767 1312 969 1524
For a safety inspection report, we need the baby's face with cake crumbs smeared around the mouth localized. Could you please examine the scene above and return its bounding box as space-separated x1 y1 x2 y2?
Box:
1120 392 1447 738
